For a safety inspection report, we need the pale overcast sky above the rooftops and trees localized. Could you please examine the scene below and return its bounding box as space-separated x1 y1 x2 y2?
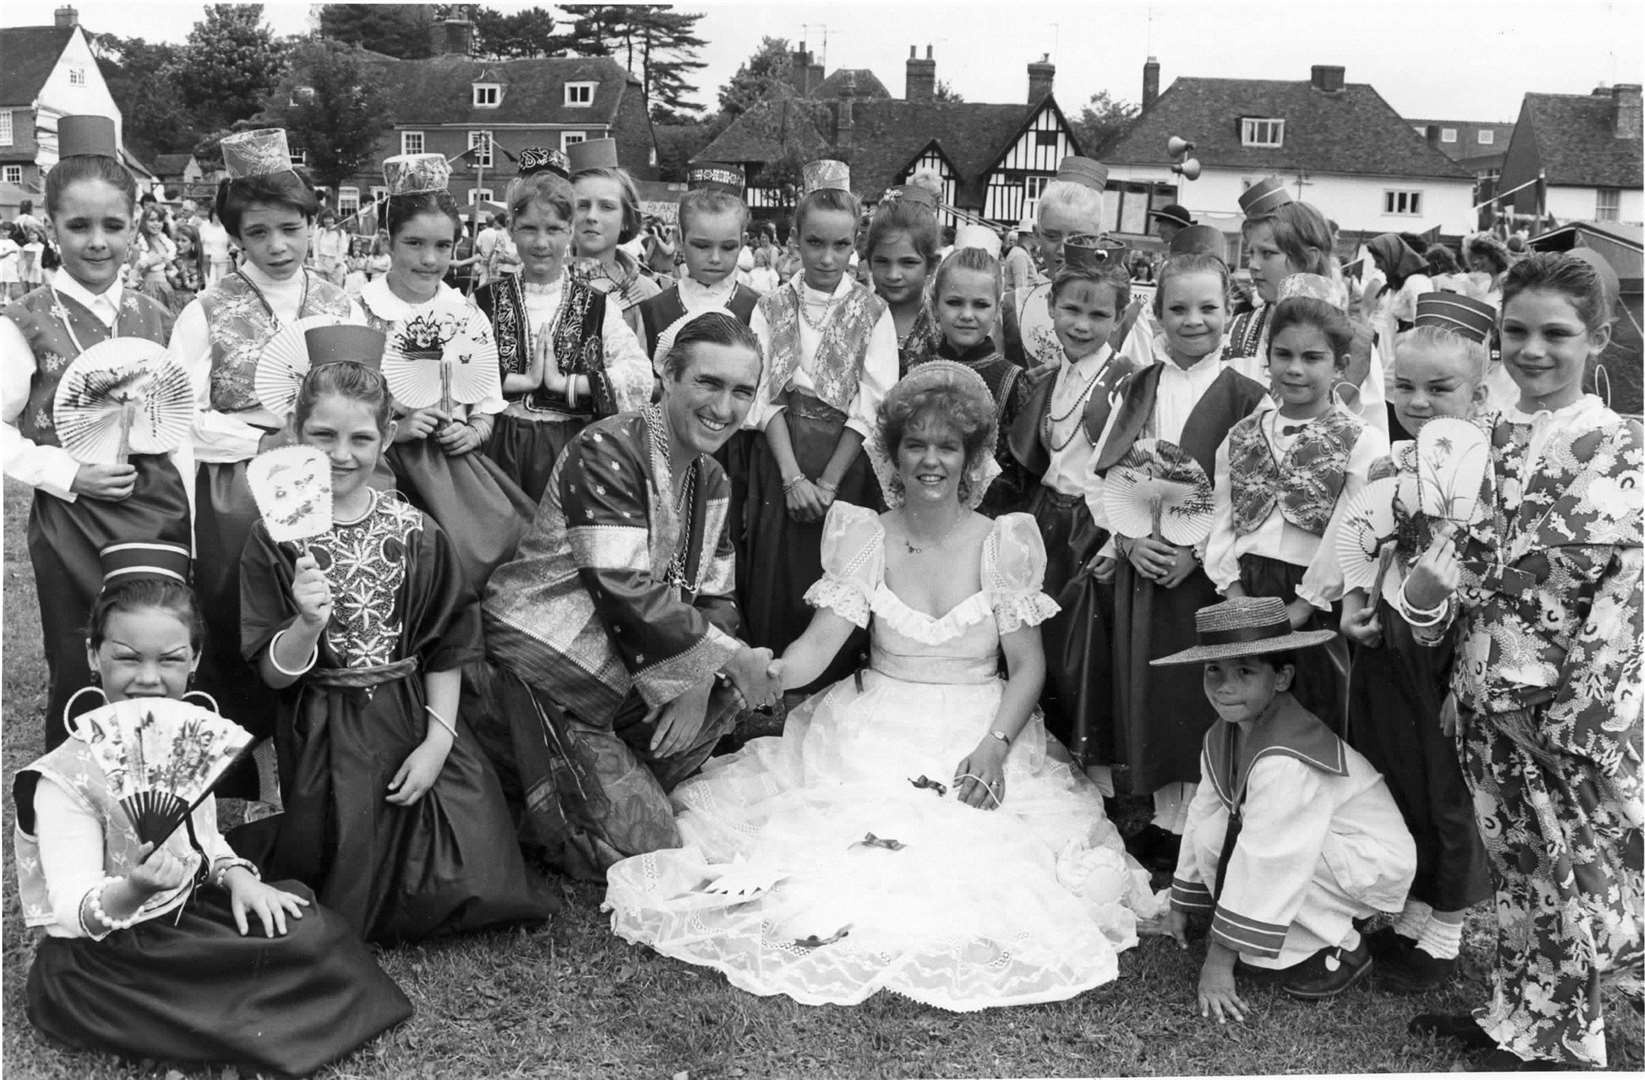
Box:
0 0 1645 122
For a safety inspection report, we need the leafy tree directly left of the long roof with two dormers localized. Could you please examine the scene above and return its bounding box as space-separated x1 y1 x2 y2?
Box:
257 38 393 191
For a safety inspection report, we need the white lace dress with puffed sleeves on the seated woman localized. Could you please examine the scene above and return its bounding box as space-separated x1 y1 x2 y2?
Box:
605 503 1158 1011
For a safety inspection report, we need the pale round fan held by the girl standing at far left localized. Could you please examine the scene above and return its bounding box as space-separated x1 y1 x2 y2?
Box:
51 337 194 465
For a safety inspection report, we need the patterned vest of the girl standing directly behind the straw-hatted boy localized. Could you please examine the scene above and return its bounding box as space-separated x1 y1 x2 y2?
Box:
1229 406 1365 536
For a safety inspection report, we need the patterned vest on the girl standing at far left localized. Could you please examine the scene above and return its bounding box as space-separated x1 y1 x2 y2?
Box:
0 288 171 445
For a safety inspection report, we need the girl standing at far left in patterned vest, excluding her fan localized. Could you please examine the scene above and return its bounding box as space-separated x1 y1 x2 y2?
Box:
0 117 192 748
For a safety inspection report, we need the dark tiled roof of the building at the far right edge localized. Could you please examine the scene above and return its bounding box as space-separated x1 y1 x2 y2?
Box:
1520 94 1640 187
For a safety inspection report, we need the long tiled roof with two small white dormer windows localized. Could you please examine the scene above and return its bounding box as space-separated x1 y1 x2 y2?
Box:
368 56 640 127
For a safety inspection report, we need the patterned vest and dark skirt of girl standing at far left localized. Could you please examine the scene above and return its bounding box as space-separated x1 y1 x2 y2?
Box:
0 288 189 748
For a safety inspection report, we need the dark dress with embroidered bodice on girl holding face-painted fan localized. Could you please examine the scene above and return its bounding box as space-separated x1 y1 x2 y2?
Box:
240 495 556 942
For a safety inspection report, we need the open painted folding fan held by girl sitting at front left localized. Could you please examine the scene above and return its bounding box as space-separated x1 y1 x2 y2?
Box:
74 697 253 847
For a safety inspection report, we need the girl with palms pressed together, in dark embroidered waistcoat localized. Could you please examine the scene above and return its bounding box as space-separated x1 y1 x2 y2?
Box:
474 148 653 501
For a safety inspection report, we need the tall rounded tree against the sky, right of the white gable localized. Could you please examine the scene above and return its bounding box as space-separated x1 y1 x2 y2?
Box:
173 3 285 130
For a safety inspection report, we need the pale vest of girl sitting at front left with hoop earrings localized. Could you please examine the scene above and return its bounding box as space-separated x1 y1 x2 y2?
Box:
12 738 201 925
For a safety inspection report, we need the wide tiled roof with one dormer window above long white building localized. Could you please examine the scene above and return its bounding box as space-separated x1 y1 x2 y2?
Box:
1102 77 1469 179
